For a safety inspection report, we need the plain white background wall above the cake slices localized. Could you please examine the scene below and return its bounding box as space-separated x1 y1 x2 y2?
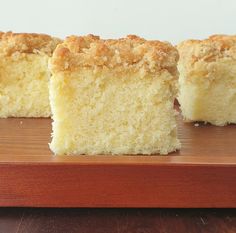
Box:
0 0 236 43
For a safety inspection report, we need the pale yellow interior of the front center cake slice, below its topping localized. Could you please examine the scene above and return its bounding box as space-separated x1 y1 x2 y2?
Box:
50 68 180 155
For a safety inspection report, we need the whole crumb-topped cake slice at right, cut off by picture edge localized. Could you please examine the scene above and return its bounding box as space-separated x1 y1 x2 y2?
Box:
178 35 236 126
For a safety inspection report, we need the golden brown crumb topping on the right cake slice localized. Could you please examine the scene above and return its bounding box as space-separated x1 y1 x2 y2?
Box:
177 35 236 65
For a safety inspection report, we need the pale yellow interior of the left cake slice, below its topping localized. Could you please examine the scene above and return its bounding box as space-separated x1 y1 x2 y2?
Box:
0 53 51 117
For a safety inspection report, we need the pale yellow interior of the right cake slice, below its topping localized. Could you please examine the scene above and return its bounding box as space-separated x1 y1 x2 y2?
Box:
178 56 236 126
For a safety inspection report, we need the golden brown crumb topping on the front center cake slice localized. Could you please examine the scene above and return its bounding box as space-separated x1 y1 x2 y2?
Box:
51 35 178 73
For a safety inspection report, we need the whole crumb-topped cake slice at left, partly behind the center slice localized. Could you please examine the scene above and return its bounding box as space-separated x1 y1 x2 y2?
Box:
0 32 60 118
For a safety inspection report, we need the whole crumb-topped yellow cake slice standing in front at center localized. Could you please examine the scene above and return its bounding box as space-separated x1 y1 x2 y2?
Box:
50 35 180 155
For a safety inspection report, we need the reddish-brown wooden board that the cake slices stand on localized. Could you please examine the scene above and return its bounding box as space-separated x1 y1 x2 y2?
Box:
0 114 236 207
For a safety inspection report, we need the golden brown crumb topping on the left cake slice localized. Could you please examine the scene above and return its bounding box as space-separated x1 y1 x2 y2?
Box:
0 32 62 55
